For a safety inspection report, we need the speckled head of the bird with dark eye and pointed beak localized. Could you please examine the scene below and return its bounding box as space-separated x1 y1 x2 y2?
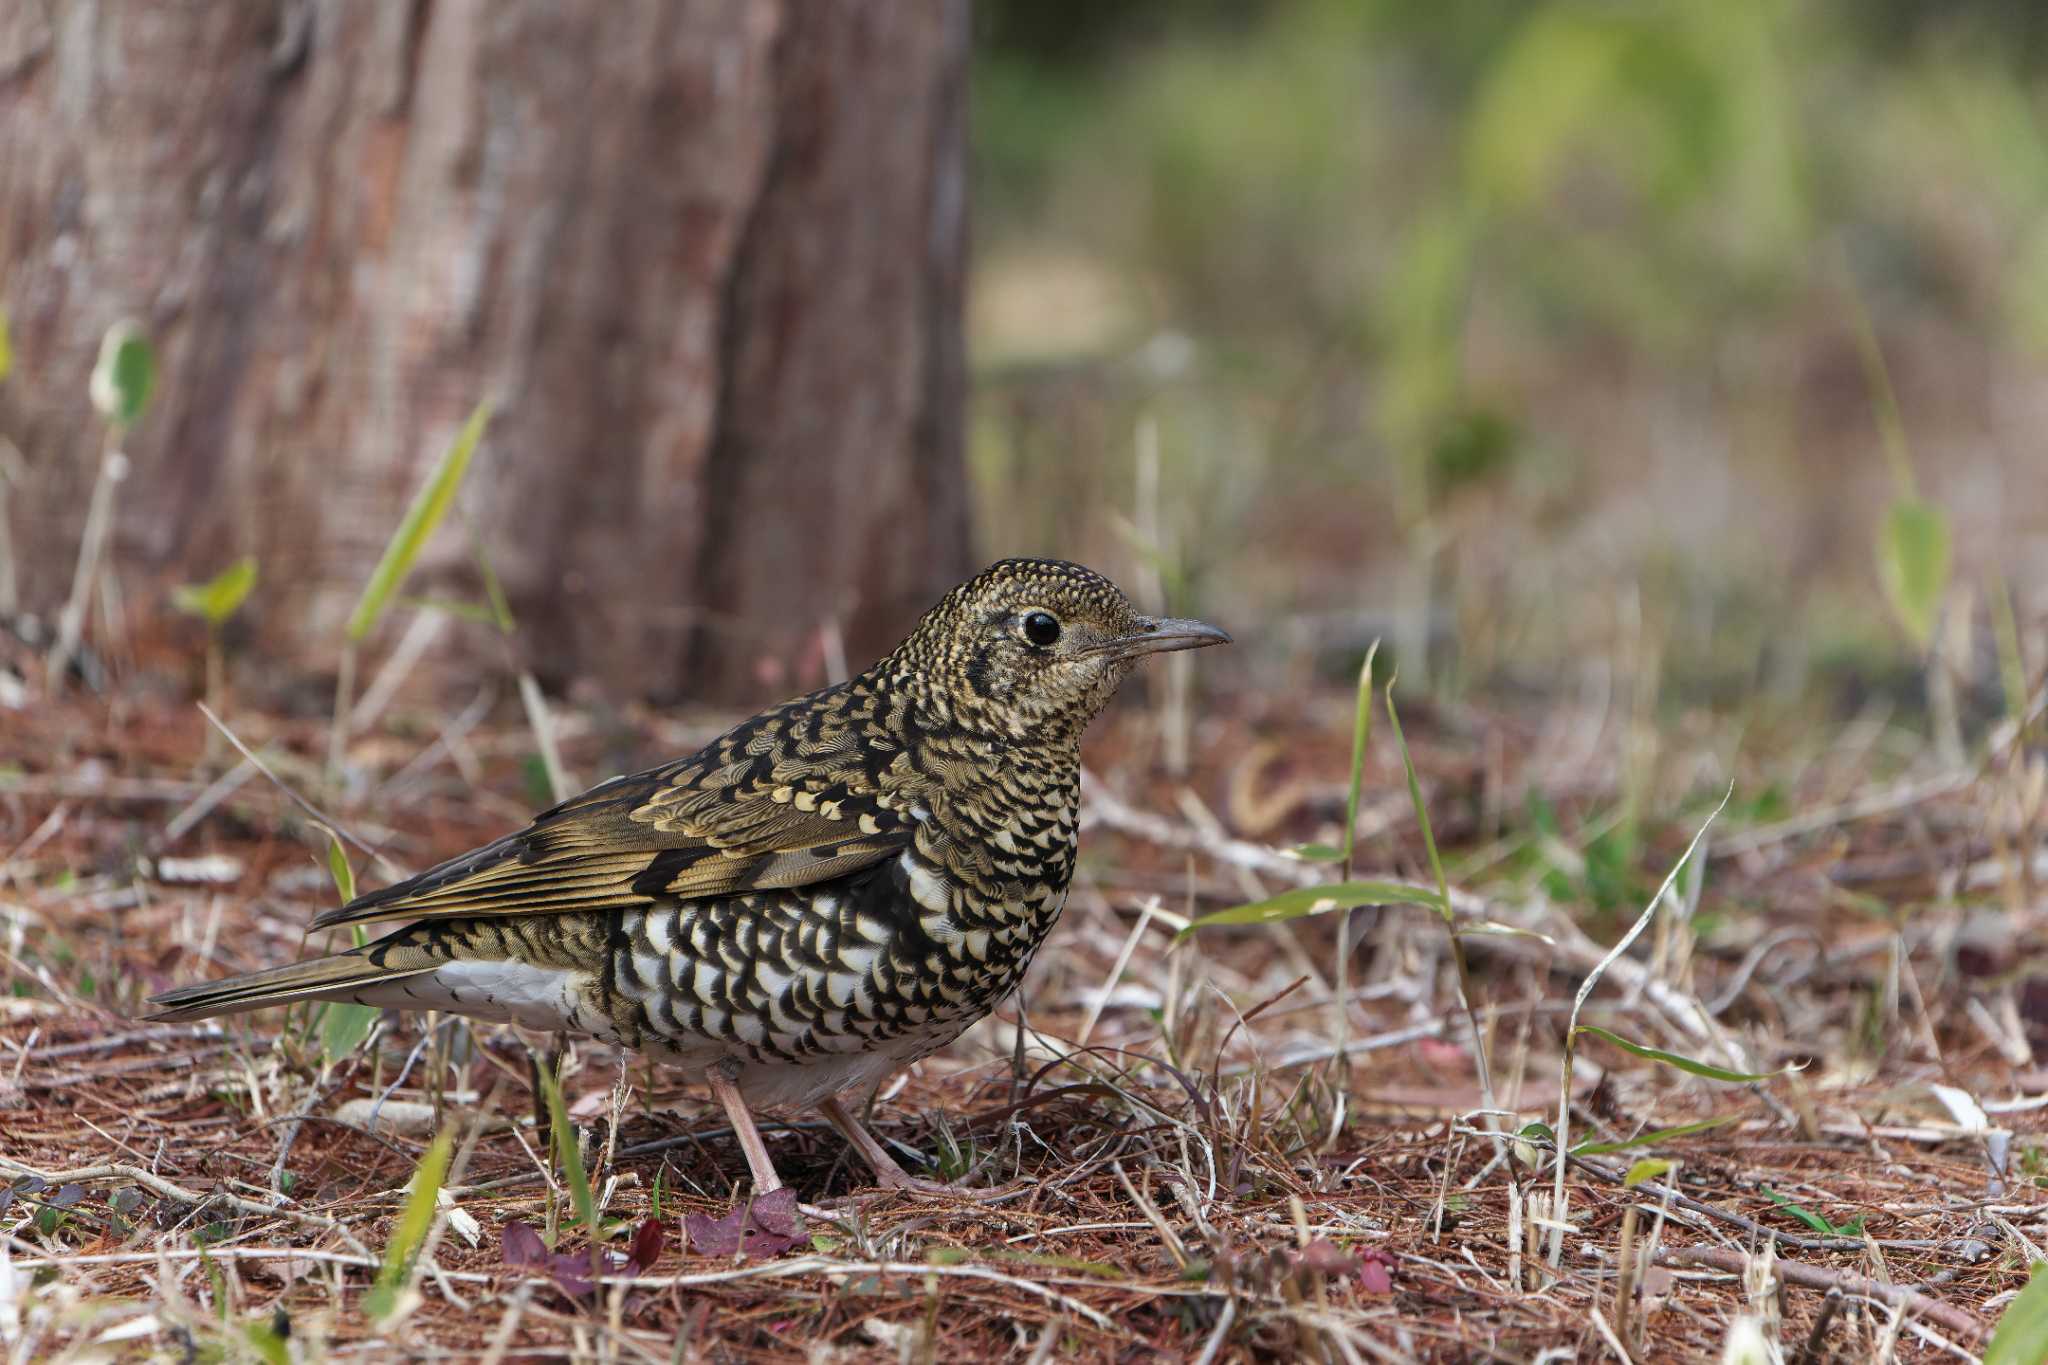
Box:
891 559 1231 743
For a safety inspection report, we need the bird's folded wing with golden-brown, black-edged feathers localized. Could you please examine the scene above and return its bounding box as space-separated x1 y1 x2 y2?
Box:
313 704 913 929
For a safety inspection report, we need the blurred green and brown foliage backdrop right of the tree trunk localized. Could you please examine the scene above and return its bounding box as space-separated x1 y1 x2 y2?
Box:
971 0 2048 720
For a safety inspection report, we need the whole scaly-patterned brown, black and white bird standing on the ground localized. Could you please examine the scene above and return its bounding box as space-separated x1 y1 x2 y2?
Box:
150 559 1231 1193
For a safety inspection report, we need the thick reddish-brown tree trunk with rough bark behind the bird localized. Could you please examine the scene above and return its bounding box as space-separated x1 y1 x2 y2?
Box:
0 0 969 698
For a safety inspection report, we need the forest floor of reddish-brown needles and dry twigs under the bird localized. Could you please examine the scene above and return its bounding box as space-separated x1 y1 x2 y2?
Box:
0 675 2048 1361
